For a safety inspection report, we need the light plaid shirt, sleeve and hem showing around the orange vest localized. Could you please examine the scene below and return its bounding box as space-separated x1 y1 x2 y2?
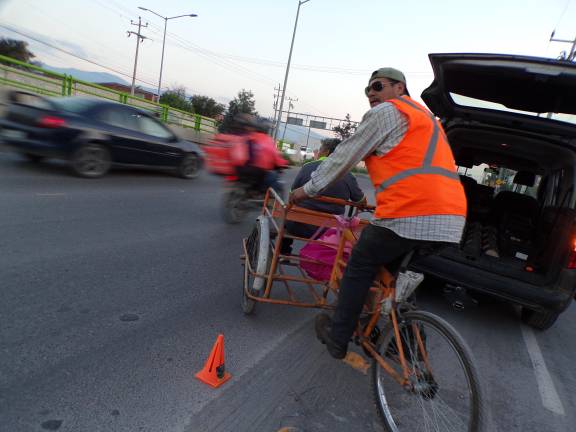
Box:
304 102 466 243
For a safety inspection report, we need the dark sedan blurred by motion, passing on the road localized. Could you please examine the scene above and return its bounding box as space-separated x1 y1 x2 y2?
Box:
0 92 204 179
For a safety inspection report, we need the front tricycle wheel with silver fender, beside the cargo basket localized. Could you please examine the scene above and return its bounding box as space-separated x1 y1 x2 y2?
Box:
242 216 272 315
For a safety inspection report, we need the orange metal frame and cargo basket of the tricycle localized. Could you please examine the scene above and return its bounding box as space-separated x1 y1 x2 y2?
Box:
241 189 427 386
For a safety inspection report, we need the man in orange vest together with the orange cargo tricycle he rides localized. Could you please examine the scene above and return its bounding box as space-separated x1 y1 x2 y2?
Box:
236 68 482 431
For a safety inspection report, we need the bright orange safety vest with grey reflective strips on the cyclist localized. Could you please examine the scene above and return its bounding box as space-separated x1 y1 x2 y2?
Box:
364 96 466 219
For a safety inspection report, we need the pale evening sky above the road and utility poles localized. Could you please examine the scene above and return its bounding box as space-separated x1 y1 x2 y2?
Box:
0 0 576 121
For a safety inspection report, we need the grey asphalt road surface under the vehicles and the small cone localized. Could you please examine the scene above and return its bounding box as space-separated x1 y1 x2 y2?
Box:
0 152 576 432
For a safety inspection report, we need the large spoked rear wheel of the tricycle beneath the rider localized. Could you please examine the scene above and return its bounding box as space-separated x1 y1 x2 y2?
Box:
372 311 482 432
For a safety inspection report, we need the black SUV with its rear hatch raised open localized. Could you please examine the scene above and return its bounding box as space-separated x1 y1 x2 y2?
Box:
416 54 576 330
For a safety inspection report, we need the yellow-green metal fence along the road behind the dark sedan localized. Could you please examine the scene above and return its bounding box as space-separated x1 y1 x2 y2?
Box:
0 55 217 134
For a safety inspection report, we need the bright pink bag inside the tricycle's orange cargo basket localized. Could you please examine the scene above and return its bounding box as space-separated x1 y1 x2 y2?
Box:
300 216 360 282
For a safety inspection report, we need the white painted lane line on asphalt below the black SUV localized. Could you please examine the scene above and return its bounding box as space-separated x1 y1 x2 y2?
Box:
522 325 565 416
